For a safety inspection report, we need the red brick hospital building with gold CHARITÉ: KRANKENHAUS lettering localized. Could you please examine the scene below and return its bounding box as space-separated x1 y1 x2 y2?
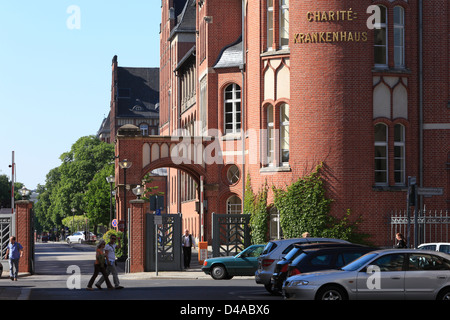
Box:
154 0 450 245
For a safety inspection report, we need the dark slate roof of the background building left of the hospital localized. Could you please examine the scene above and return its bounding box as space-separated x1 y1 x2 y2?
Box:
117 67 159 118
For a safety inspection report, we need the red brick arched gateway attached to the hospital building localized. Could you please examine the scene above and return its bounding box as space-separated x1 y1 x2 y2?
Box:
115 125 224 241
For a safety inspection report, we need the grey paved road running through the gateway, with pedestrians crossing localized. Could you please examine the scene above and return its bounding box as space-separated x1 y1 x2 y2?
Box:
0 243 281 301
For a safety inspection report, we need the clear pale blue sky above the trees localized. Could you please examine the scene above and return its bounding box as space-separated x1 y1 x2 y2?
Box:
0 0 161 189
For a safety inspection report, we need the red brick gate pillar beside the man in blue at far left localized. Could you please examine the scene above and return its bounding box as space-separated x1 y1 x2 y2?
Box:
14 200 33 273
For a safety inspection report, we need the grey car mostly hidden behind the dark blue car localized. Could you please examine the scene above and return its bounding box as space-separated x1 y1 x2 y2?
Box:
255 238 349 293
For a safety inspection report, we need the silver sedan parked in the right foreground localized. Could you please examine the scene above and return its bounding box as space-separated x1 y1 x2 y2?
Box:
283 249 450 300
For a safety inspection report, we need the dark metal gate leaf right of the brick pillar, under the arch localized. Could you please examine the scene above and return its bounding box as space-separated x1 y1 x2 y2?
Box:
145 213 182 271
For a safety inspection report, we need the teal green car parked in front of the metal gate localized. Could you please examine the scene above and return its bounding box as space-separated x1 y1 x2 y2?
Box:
202 244 265 280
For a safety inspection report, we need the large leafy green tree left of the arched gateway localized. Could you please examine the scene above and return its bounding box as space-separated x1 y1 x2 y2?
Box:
34 136 114 231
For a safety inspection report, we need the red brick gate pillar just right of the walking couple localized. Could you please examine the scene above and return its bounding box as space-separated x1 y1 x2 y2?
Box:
128 199 145 273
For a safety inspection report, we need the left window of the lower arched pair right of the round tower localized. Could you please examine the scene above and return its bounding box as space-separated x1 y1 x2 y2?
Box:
375 123 388 185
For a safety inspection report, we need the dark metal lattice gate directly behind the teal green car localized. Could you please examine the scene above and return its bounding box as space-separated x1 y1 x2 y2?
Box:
212 213 250 257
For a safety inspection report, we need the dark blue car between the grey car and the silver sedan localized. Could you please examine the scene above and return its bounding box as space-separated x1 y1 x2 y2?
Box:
272 242 376 294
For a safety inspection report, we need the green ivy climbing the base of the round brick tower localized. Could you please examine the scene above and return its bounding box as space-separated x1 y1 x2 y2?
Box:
244 164 368 244
